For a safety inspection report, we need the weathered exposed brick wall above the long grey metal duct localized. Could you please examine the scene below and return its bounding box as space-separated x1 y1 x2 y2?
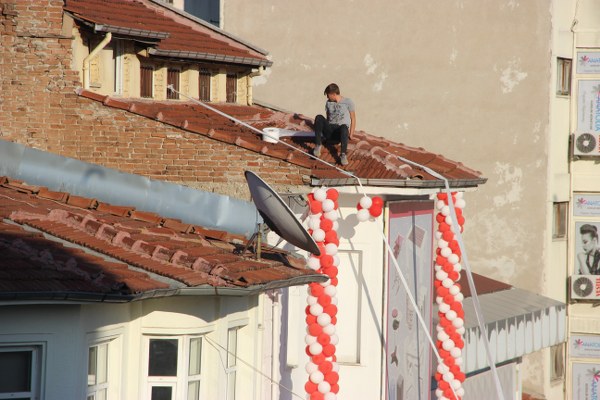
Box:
0 0 308 198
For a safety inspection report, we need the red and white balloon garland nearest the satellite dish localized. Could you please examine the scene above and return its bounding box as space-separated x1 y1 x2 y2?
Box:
304 188 340 400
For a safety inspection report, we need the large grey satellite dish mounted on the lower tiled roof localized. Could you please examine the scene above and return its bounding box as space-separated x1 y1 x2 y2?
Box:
244 171 321 256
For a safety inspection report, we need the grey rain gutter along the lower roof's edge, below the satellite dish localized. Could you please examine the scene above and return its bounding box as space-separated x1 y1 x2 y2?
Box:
0 274 329 306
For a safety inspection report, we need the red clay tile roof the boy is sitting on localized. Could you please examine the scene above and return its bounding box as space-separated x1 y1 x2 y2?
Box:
79 90 486 187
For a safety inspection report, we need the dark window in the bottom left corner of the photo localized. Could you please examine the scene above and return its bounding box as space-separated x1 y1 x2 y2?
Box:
0 346 42 400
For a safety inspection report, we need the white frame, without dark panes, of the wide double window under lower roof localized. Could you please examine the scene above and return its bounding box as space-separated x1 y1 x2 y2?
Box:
143 333 206 400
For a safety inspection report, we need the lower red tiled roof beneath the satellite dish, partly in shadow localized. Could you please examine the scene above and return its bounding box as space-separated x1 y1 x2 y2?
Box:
0 177 324 300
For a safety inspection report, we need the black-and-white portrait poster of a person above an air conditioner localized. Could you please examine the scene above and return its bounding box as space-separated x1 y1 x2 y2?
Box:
575 221 600 275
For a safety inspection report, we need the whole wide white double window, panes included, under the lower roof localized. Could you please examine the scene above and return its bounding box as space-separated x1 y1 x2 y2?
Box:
147 336 202 400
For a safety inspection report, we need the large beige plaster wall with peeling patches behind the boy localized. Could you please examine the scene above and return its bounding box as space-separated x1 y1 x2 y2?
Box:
222 0 574 398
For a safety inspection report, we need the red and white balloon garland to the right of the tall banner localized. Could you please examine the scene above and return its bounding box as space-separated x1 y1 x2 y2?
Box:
434 192 466 400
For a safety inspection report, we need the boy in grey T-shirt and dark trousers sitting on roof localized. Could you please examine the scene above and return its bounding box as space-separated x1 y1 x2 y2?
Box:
313 83 356 165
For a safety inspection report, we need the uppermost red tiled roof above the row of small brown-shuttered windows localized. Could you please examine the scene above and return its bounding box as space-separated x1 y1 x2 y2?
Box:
64 0 271 66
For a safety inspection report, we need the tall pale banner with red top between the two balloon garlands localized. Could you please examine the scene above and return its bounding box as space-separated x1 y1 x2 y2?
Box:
385 201 434 400
